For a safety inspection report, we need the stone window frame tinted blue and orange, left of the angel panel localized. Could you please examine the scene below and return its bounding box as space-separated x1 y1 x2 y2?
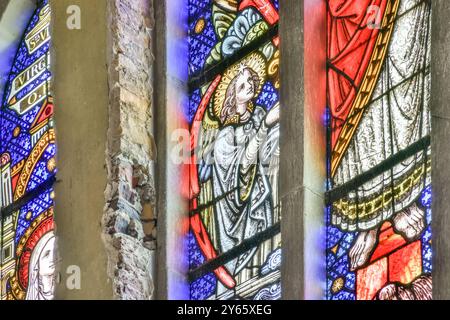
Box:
154 0 190 300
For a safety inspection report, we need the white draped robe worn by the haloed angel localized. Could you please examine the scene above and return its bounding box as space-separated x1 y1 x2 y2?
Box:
212 107 279 293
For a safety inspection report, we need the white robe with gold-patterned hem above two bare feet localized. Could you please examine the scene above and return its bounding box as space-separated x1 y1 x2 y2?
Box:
332 0 430 231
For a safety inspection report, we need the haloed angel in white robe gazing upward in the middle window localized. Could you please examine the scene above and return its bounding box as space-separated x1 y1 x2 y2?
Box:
191 52 280 295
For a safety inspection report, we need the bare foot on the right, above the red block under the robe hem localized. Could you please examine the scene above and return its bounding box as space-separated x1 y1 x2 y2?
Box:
393 204 425 241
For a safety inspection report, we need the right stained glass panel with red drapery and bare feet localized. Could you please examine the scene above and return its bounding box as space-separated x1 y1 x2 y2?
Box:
326 0 432 300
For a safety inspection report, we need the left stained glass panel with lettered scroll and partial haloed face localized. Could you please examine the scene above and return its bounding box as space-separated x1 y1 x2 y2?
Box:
0 0 56 300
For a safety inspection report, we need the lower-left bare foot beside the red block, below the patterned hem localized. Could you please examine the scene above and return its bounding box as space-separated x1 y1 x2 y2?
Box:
349 229 378 271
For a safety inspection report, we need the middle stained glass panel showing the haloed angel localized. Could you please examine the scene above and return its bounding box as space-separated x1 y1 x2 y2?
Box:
185 0 281 300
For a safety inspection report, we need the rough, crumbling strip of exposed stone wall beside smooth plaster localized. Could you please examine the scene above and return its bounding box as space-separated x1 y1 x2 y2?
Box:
102 0 157 300
